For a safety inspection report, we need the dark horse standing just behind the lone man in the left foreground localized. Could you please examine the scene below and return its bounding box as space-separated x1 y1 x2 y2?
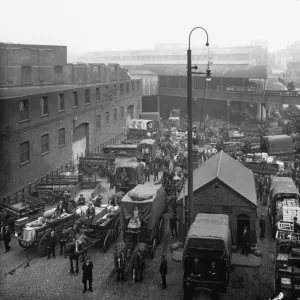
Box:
64 234 87 275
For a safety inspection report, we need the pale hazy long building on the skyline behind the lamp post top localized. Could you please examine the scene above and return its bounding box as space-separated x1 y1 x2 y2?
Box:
80 44 268 67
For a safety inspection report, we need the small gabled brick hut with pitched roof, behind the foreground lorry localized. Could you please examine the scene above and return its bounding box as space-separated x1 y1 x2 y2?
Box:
177 151 257 247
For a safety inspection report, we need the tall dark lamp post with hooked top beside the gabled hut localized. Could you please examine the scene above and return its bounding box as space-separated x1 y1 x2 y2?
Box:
186 27 211 230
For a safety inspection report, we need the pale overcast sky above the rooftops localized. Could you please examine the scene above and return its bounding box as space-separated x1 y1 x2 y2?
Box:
0 0 300 53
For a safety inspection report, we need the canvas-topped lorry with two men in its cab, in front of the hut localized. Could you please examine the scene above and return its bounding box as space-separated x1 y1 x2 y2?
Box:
182 213 232 299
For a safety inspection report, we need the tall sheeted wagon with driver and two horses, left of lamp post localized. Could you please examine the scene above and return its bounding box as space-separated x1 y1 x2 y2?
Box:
115 184 167 281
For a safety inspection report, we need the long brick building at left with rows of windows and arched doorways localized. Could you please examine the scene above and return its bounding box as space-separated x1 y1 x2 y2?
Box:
0 44 142 195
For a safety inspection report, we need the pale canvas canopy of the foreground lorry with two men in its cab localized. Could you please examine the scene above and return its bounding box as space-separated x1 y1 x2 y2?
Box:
183 213 232 259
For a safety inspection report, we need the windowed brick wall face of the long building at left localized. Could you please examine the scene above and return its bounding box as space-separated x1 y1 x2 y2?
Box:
0 87 142 193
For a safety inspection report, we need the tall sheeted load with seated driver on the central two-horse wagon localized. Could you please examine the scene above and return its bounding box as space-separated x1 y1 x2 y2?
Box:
120 184 167 239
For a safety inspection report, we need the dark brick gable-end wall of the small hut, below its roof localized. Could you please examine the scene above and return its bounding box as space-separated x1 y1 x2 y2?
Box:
178 180 257 247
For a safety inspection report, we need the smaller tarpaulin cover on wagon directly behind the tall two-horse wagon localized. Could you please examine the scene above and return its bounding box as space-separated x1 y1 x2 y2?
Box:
115 161 142 185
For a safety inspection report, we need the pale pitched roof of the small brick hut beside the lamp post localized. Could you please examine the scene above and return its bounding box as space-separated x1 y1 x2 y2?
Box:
179 151 257 205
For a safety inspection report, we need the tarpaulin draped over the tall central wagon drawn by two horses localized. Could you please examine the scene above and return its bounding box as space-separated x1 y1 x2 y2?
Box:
120 184 167 230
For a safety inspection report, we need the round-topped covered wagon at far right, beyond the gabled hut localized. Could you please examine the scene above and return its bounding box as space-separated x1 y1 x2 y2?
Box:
260 134 295 155
